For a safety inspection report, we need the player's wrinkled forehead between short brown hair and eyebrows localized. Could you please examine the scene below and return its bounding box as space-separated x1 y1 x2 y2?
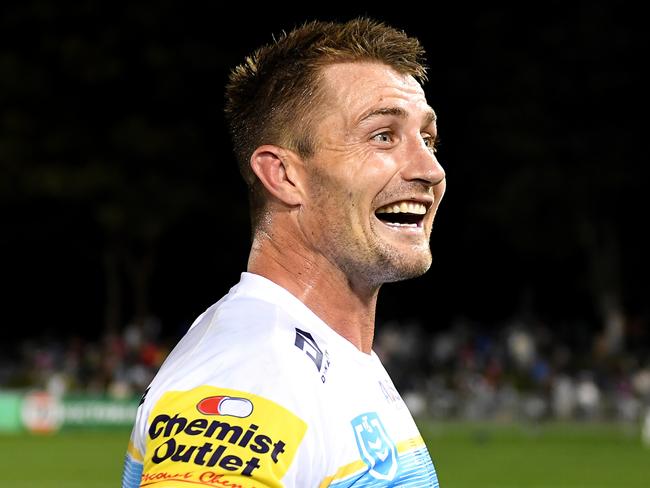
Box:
322 62 431 123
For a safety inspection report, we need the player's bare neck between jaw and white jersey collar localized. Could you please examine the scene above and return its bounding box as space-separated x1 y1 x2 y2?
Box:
248 226 379 354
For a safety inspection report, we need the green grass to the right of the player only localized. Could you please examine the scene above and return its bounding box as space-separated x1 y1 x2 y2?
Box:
420 424 650 488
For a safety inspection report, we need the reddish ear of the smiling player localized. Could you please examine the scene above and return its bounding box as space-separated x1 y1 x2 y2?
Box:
250 144 302 205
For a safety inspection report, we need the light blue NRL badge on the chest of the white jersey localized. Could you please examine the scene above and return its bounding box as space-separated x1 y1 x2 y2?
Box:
352 412 399 481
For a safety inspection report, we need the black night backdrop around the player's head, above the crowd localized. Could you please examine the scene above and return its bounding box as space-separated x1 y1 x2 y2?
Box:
0 1 650 342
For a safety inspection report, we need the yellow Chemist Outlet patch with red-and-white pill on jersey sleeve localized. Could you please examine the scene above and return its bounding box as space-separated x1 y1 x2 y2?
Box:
143 386 306 486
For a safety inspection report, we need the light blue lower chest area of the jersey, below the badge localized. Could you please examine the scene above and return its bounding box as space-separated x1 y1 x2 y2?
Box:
329 447 439 488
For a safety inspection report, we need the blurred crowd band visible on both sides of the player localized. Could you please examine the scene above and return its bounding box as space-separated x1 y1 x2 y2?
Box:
0 312 650 422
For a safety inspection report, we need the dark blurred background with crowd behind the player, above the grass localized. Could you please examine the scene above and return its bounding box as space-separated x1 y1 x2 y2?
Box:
0 0 650 487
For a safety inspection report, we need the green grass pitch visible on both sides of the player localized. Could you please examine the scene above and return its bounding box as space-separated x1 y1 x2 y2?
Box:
0 422 650 488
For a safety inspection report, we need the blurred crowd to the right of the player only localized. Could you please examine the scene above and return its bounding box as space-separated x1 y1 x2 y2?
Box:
375 312 650 422
